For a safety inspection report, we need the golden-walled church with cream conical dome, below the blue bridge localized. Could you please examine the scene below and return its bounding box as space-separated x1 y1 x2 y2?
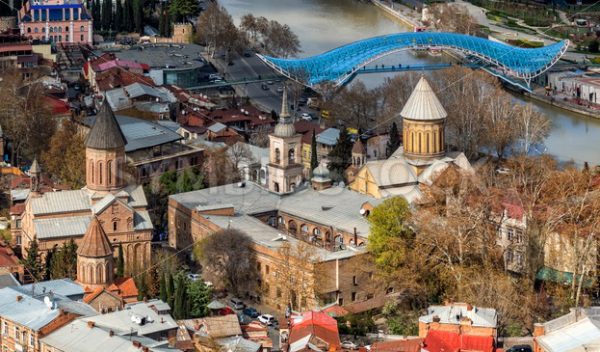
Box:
350 76 471 202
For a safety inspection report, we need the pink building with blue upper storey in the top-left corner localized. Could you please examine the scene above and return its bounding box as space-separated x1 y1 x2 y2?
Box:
19 0 93 44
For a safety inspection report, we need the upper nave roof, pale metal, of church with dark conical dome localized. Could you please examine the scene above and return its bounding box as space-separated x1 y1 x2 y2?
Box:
30 190 90 215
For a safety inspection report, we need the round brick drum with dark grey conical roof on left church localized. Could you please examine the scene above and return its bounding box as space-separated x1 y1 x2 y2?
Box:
85 98 127 192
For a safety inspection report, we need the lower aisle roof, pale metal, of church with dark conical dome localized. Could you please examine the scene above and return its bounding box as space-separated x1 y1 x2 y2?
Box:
33 215 92 239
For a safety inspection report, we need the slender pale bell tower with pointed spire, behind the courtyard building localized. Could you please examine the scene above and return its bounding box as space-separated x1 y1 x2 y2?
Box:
268 85 303 193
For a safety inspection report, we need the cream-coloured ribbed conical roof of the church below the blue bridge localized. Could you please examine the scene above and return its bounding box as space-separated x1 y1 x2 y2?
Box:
400 77 448 120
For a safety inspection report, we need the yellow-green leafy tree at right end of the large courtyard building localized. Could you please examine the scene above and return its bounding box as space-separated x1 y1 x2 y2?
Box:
367 197 413 274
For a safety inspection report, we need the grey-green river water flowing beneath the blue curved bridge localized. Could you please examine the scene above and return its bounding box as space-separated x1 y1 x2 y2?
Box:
219 0 600 165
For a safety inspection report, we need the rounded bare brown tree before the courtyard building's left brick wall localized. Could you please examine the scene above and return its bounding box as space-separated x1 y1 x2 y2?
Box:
194 229 257 294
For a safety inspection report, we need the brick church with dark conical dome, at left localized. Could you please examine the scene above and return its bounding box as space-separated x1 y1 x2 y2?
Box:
15 100 153 280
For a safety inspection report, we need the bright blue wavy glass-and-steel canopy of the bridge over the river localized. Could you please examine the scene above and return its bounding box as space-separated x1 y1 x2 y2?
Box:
258 32 569 86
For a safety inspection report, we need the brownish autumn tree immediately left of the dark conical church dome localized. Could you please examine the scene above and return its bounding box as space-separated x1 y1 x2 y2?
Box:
42 120 85 189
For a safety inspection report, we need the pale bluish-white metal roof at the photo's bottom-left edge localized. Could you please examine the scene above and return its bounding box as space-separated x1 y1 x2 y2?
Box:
0 287 59 331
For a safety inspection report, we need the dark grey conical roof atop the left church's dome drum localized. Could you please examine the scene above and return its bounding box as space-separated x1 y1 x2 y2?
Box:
85 98 127 150
